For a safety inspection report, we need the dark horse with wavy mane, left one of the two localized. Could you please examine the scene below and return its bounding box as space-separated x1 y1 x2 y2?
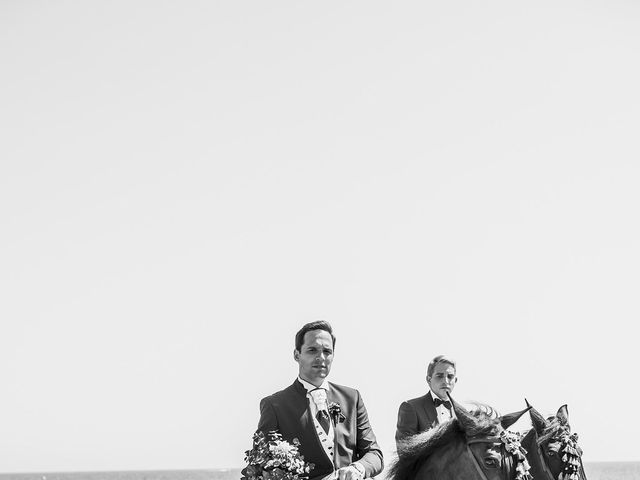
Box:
389 400 531 480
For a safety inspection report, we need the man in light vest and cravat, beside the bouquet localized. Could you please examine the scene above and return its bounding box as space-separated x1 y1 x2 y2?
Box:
258 321 383 480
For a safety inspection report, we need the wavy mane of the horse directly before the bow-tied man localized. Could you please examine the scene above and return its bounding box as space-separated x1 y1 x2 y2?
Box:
388 404 502 480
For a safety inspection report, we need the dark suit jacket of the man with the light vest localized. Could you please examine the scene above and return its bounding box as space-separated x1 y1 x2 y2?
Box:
258 379 383 478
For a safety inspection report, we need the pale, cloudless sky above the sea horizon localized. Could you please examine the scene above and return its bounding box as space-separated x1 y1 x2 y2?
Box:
0 0 640 472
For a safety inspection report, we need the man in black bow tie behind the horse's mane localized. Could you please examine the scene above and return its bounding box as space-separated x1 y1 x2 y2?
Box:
396 355 458 448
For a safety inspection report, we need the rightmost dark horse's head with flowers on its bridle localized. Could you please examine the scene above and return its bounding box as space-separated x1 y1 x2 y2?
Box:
521 400 587 480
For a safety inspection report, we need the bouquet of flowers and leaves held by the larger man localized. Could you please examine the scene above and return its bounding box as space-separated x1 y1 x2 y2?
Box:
241 432 314 480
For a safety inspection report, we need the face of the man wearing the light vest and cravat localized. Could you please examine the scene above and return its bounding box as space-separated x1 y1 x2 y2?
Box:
293 330 333 387
